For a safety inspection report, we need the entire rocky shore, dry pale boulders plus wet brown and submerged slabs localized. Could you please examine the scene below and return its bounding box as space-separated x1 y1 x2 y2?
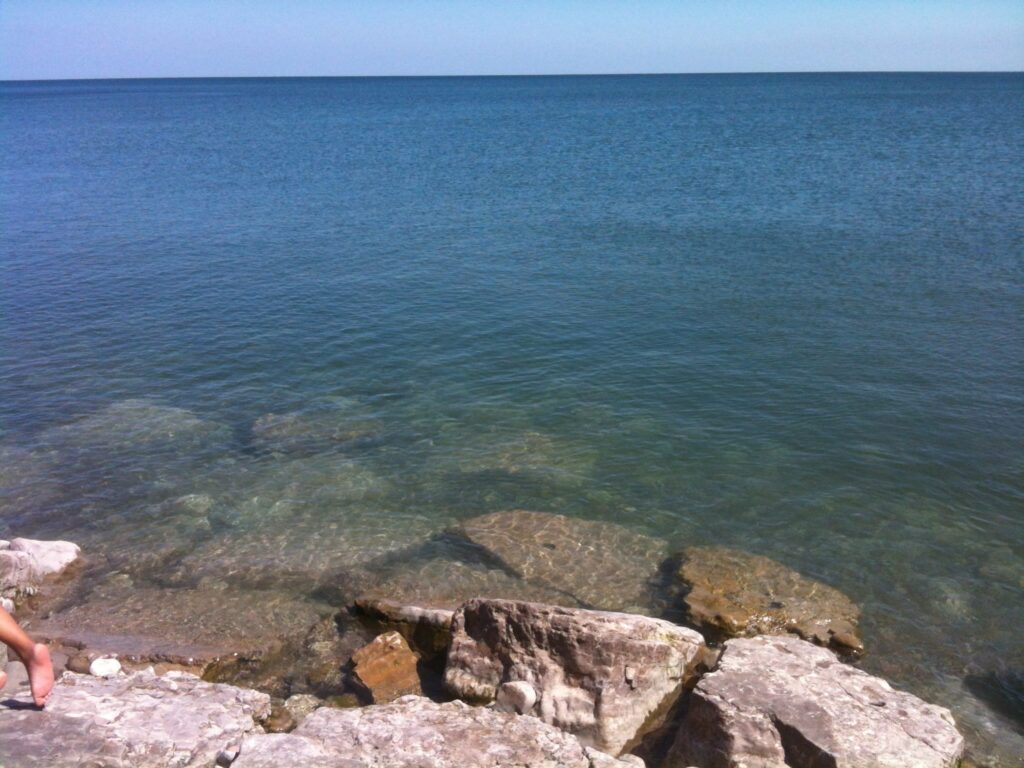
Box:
0 520 964 768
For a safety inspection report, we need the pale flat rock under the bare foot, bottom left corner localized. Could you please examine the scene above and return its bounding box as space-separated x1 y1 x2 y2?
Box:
0 672 270 768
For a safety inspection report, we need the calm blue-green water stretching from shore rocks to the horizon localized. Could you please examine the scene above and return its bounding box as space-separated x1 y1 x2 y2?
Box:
0 75 1024 765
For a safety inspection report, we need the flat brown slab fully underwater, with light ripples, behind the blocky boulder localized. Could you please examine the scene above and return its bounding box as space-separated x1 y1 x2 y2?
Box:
453 510 668 613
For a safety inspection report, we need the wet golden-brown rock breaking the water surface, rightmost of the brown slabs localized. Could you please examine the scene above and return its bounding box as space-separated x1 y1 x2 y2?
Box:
679 547 864 655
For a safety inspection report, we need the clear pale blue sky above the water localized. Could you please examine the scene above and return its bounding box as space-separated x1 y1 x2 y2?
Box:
0 0 1024 80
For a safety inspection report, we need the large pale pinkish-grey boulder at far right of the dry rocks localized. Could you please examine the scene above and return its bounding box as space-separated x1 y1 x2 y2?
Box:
668 636 964 768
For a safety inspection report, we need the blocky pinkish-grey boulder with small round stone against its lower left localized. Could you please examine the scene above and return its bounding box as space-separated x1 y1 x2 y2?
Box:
444 599 707 755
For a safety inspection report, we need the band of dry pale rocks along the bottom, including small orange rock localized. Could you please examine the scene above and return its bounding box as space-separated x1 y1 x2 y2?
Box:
0 545 964 768
